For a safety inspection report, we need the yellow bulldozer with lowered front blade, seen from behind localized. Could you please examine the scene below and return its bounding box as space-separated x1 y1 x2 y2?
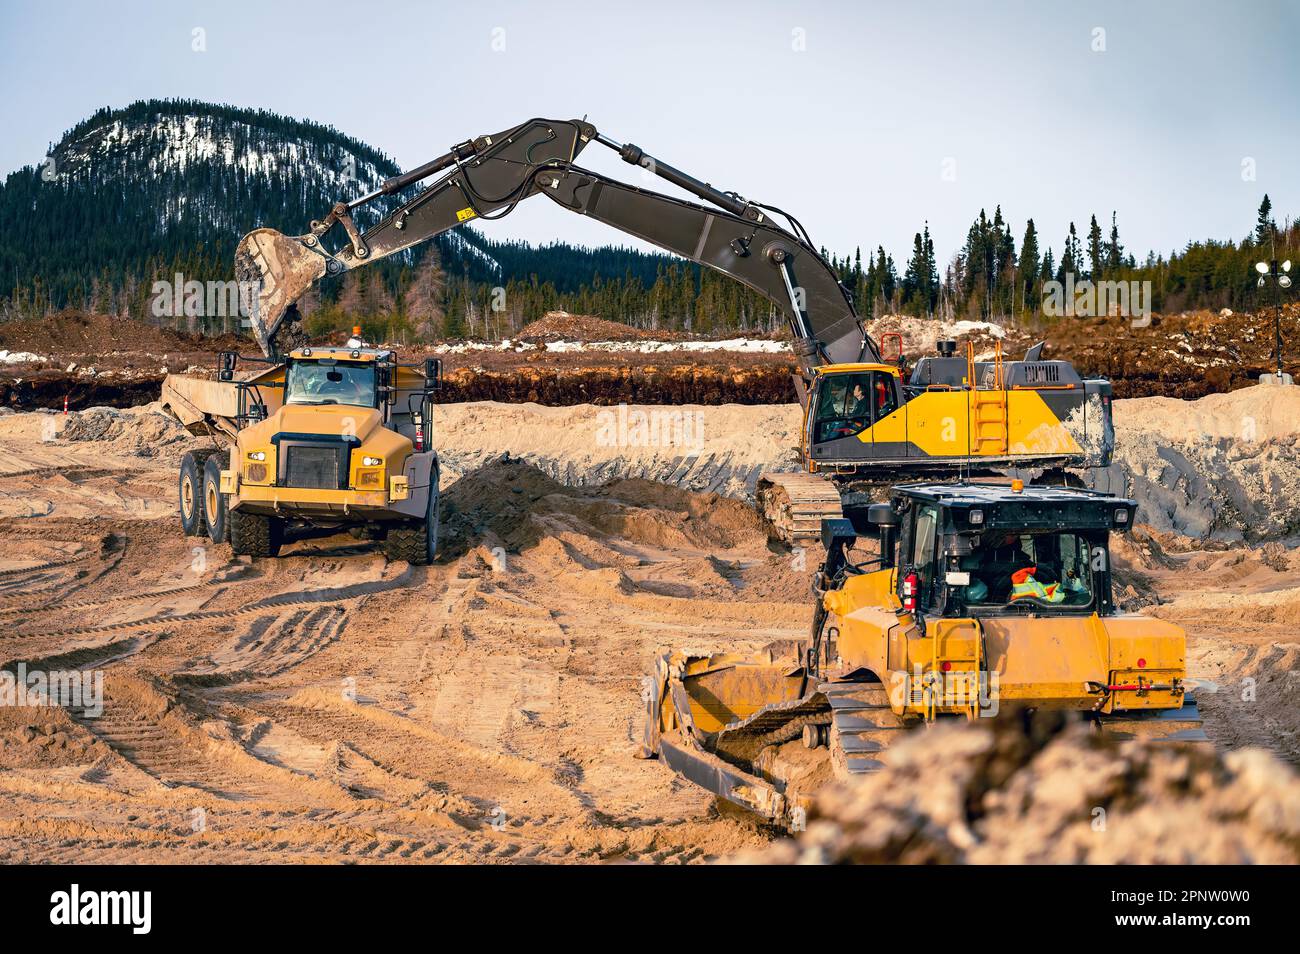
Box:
638 481 1206 827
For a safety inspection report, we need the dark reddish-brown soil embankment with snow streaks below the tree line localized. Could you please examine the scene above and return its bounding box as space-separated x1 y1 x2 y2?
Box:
0 305 1300 409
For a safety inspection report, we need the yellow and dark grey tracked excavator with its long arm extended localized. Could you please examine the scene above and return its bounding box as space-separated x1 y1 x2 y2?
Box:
235 118 1114 546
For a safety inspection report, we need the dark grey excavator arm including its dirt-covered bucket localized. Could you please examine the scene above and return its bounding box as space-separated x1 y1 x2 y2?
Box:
235 120 880 377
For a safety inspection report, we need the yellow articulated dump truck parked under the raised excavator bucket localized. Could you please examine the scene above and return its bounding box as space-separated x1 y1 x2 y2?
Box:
161 337 441 564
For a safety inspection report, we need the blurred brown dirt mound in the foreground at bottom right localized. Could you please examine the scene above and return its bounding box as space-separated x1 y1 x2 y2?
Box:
733 712 1300 864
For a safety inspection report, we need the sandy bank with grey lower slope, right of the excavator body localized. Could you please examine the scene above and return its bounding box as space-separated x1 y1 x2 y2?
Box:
1099 386 1300 542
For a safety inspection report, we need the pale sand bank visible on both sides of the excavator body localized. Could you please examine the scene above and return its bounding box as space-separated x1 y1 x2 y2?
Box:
436 387 1300 542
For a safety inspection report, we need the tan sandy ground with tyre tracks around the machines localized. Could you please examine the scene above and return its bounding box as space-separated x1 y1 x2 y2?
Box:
0 397 1300 863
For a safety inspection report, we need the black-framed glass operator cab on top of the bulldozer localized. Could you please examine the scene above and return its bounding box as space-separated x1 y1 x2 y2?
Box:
881 483 1135 617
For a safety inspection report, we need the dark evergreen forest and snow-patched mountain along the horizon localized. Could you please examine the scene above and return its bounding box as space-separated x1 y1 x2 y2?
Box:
0 100 1300 341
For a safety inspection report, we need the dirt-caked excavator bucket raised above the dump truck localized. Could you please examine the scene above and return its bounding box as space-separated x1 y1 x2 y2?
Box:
235 229 325 357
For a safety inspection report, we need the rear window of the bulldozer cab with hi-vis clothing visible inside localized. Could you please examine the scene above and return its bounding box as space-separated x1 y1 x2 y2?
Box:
959 532 1093 612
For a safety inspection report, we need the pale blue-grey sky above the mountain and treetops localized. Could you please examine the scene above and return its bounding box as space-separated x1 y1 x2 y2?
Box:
0 0 1300 261
